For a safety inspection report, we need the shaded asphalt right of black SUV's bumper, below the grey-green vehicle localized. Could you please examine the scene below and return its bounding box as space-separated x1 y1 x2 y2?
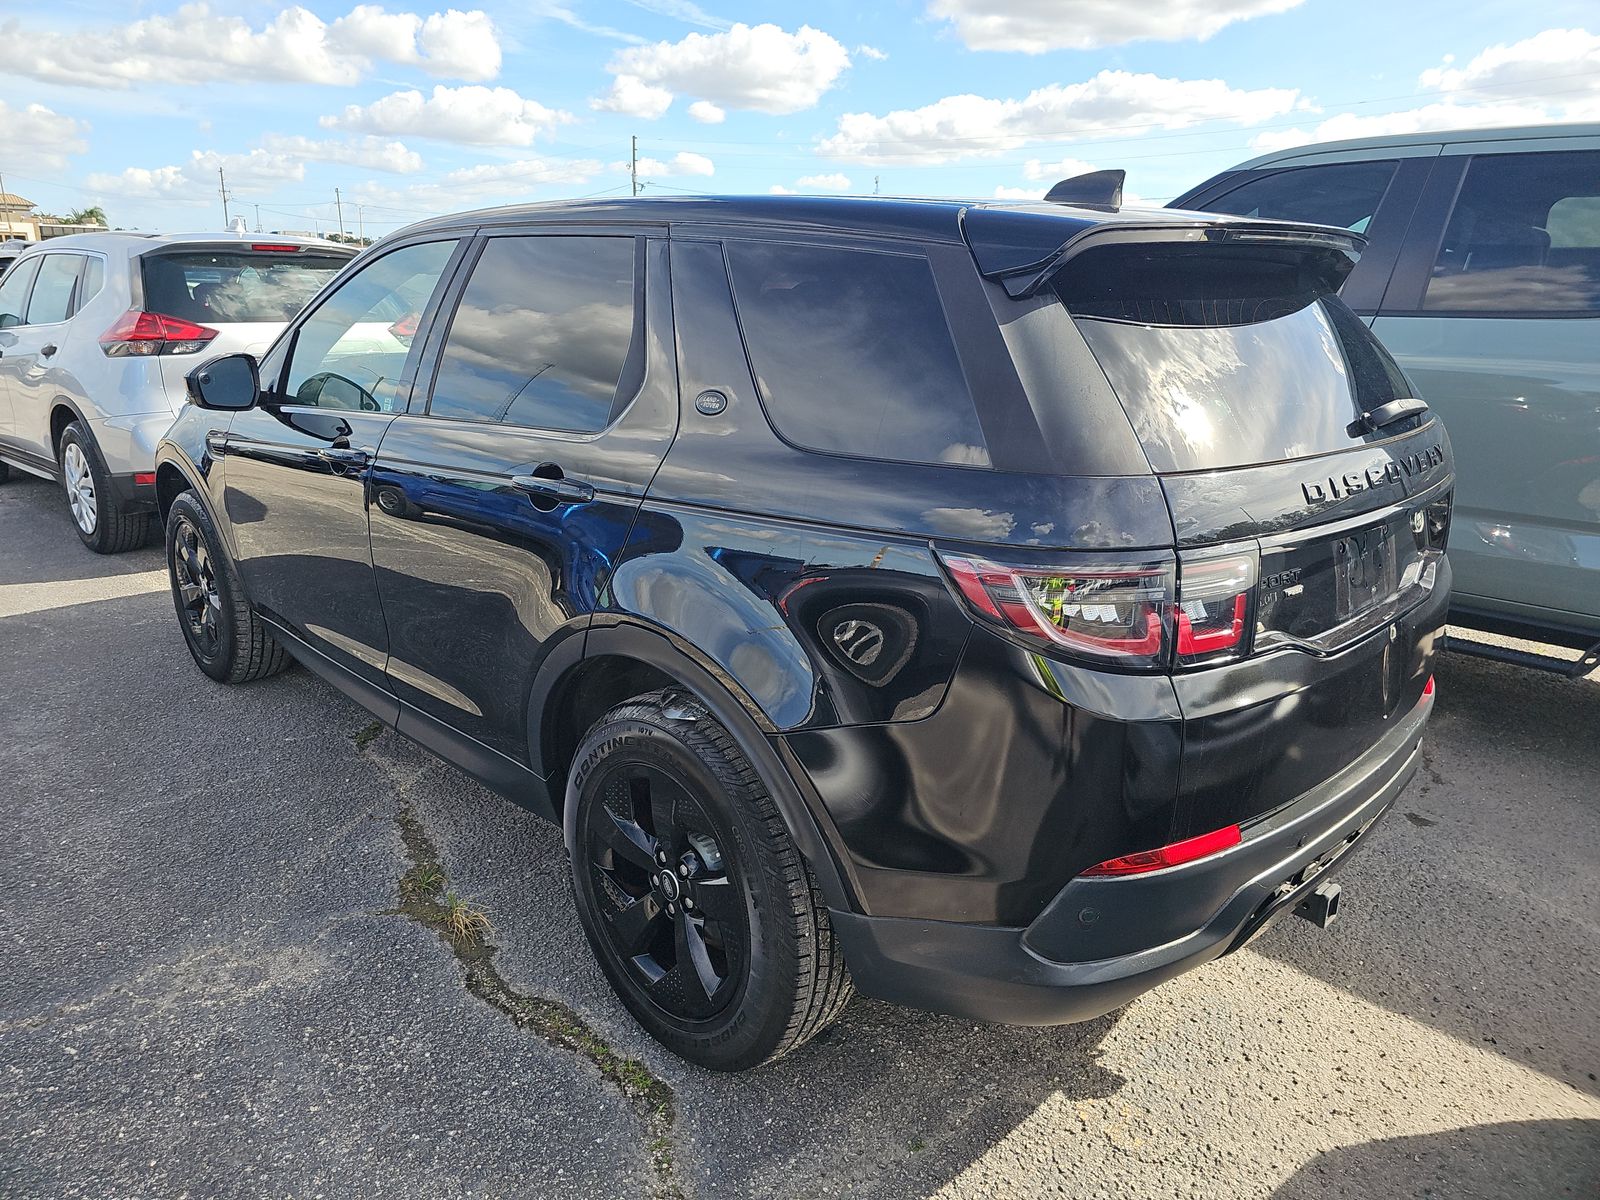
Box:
1251 654 1600 1094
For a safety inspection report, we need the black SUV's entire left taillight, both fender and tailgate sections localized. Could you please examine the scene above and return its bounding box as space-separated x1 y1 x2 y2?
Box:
939 547 1259 670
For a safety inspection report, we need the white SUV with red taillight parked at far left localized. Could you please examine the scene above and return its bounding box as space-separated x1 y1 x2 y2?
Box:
0 234 354 554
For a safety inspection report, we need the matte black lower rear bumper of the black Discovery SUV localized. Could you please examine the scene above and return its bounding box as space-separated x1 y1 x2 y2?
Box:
830 698 1434 1026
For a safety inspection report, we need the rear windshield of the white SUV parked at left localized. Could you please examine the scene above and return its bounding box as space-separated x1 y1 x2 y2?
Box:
141 250 349 325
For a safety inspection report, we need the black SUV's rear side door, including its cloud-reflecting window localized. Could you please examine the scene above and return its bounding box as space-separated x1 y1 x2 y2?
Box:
371 229 678 762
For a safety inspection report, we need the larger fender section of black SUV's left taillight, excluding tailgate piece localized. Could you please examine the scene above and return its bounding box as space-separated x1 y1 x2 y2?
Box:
941 555 1173 667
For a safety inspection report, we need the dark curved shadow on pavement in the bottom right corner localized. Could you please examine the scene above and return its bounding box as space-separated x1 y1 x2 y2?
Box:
1272 1118 1600 1200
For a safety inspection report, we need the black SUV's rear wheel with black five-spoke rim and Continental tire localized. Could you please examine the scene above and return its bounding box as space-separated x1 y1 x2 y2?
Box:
568 691 853 1070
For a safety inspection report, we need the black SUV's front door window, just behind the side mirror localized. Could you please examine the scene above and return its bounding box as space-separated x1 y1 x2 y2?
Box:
274 238 456 413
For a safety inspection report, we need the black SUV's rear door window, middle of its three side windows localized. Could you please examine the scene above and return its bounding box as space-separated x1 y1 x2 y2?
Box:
427 235 638 432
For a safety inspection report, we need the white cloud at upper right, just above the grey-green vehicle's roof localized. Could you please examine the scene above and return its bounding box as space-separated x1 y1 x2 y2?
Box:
1250 29 1600 152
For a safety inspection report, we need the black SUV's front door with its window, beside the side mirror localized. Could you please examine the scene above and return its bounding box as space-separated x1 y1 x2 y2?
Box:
217 235 462 686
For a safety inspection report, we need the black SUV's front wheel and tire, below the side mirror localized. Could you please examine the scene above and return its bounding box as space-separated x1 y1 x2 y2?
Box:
166 491 291 683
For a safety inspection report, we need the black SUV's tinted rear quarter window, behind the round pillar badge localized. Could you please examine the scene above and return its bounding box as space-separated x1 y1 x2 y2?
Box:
728 242 989 467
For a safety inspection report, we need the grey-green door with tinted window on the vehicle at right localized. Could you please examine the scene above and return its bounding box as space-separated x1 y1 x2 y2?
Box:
1373 145 1600 638
